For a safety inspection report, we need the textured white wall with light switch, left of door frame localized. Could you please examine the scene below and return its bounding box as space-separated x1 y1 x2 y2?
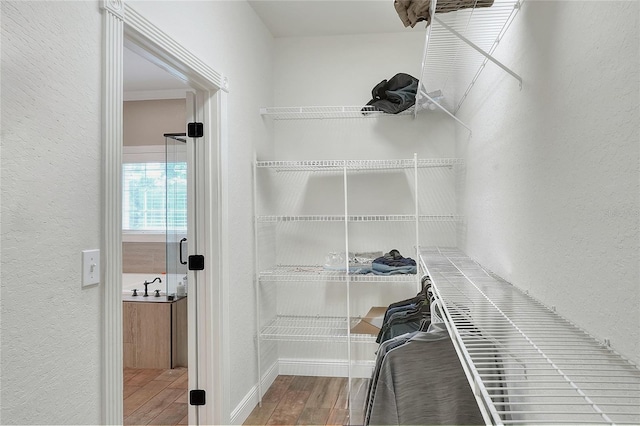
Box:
0 1 102 424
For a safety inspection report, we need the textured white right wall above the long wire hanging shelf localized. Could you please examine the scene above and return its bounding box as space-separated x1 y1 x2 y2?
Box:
459 1 640 363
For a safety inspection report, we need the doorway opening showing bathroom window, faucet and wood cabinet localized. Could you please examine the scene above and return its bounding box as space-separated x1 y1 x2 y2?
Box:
122 42 193 425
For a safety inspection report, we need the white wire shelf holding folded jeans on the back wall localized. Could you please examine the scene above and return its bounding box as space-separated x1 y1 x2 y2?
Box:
260 265 416 283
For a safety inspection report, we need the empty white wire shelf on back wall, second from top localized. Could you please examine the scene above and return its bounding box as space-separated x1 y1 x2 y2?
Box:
256 158 464 172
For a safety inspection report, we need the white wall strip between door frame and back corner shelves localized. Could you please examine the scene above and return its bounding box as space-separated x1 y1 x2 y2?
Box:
129 1 273 414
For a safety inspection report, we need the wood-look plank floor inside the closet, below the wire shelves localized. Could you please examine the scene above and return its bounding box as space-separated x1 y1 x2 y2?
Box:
244 376 366 425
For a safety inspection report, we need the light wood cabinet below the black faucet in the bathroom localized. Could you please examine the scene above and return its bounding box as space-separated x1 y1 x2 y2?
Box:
122 297 187 368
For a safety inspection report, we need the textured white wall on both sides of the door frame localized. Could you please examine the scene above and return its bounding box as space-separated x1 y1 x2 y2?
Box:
1 1 273 424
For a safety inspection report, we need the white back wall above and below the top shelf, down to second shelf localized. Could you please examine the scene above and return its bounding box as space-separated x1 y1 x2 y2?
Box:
274 32 455 159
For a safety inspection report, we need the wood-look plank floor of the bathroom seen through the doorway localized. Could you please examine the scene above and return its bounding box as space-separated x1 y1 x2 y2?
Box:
124 367 188 425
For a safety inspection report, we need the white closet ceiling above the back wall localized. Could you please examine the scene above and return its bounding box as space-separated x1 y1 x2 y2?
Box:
249 0 424 37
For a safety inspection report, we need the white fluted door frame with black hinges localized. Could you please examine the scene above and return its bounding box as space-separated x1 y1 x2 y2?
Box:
101 0 230 424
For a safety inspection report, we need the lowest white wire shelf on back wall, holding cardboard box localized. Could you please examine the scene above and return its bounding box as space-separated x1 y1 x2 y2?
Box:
261 315 376 343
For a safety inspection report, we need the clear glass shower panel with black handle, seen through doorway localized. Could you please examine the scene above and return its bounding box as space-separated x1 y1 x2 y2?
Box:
164 133 187 295
